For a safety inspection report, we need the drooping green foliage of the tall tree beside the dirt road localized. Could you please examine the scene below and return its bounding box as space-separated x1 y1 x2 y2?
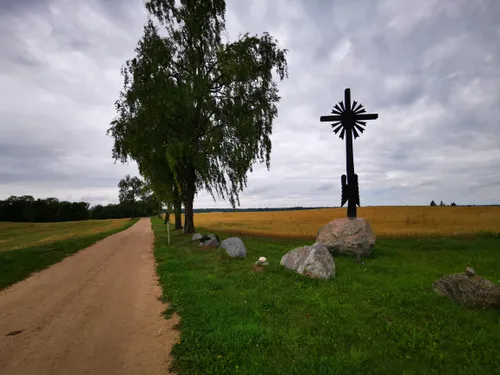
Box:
108 0 287 231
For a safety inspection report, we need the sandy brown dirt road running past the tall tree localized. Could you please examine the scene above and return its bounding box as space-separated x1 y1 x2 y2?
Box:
0 219 178 375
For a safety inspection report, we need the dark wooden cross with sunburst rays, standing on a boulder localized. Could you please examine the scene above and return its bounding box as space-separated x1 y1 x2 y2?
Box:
320 88 378 218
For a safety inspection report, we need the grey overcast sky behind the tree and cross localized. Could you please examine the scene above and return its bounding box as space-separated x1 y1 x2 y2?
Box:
0 0 500 208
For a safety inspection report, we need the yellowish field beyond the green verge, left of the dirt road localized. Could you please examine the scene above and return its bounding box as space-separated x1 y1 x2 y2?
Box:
0 219 133 251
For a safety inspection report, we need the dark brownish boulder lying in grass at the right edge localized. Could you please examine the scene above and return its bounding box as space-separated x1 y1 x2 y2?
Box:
432 267 500 308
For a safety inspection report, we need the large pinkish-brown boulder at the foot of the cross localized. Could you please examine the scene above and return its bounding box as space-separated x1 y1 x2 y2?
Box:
316 218 375 261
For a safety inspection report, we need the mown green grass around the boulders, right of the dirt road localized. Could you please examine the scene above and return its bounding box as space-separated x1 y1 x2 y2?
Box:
152 219 500 375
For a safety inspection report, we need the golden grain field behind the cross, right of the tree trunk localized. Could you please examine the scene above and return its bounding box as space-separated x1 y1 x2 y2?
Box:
178 206 500 239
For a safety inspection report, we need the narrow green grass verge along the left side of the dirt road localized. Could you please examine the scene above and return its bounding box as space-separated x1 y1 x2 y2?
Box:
0 219 138 290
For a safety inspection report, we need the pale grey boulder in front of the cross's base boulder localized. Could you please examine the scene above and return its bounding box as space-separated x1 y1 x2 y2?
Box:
280 242 335 279
